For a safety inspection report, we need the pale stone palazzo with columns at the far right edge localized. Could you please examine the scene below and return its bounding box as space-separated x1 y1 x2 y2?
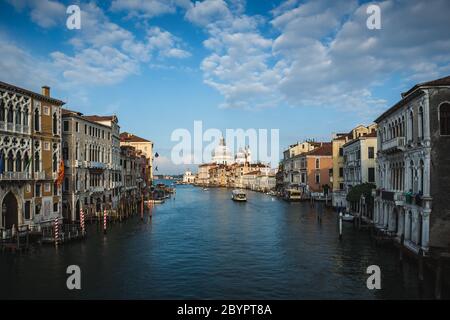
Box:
374 77 450 254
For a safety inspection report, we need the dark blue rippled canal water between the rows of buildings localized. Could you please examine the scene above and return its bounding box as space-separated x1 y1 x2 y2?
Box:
0 186 442 299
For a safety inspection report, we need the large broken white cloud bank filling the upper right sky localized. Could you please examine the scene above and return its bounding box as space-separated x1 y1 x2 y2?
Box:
196 0 450 117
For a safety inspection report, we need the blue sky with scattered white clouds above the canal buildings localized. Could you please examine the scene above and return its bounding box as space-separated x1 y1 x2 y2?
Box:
0 0 450 174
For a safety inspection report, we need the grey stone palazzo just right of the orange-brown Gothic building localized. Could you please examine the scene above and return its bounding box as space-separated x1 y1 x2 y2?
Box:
62 109 119 221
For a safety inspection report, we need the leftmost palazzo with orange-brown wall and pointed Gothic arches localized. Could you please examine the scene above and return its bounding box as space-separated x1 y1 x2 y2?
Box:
0 82 64 232
